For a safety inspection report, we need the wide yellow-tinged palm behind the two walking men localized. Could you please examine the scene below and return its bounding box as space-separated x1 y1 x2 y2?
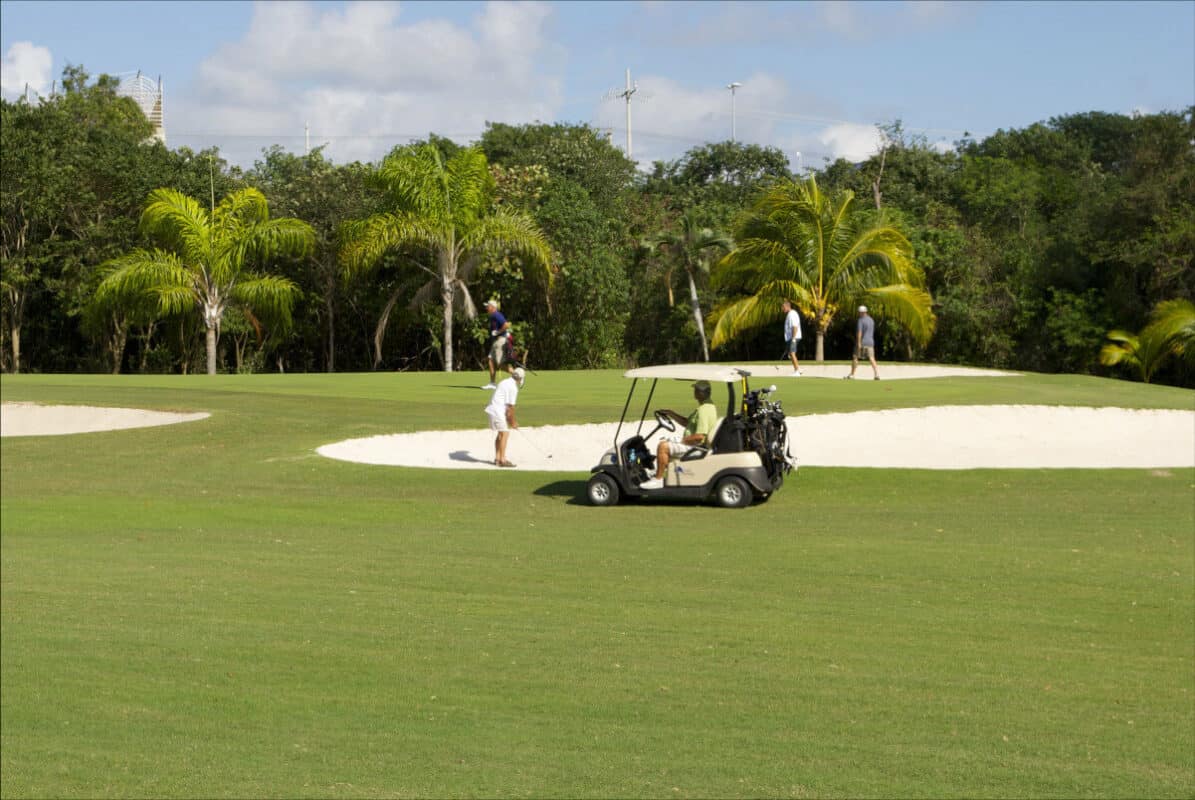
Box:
712 176 937 361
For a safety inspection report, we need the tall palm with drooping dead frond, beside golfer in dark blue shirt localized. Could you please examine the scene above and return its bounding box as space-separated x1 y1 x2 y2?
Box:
341 145 551 372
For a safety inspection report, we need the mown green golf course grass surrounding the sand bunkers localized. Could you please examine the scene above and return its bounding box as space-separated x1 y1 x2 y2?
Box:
0 371 1195 798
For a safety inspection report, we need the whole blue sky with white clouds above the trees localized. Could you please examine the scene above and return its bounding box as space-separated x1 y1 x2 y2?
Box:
0 0 1195 167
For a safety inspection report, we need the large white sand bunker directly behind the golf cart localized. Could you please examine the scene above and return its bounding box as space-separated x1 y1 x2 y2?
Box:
317 405 1195 472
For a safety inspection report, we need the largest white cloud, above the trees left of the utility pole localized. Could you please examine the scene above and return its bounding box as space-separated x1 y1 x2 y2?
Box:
167 1 563 164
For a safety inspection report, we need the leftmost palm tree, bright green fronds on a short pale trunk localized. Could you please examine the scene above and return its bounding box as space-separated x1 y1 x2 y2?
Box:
94 189 315 375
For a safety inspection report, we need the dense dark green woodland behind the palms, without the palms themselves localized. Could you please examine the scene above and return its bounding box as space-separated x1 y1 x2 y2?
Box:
0 67 1195 386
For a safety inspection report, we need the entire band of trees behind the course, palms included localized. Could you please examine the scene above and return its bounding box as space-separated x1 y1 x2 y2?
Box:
0 66 1195 386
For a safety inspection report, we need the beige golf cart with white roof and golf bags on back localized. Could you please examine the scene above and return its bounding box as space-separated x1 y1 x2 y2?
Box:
586 364 795 508
